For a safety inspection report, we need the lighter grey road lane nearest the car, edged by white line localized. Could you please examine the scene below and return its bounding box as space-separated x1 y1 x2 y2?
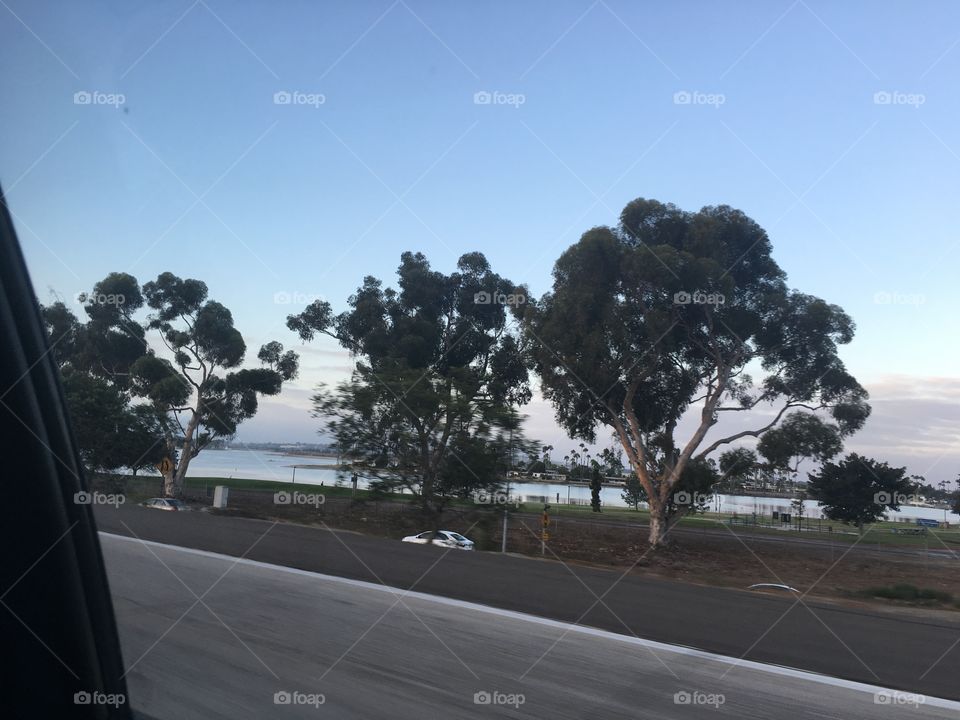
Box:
102 535 960 720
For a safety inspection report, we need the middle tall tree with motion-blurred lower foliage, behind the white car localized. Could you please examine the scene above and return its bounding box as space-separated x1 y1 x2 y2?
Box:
287 252 530 521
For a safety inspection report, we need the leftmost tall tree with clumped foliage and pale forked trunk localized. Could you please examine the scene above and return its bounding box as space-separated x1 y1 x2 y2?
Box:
43 272 298 495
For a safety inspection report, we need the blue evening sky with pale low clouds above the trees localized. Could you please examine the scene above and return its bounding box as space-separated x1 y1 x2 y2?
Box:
0 0 960 482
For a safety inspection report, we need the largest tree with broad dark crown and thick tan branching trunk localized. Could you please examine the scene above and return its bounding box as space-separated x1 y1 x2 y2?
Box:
516 199 869 545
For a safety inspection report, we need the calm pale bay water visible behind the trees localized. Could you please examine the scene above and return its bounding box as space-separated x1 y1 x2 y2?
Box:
189 450 960 525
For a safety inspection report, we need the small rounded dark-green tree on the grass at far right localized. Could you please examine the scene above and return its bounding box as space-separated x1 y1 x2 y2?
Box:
807 453 915 533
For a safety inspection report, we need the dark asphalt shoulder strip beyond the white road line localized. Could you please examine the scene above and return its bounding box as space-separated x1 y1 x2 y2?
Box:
96 506 960 699
